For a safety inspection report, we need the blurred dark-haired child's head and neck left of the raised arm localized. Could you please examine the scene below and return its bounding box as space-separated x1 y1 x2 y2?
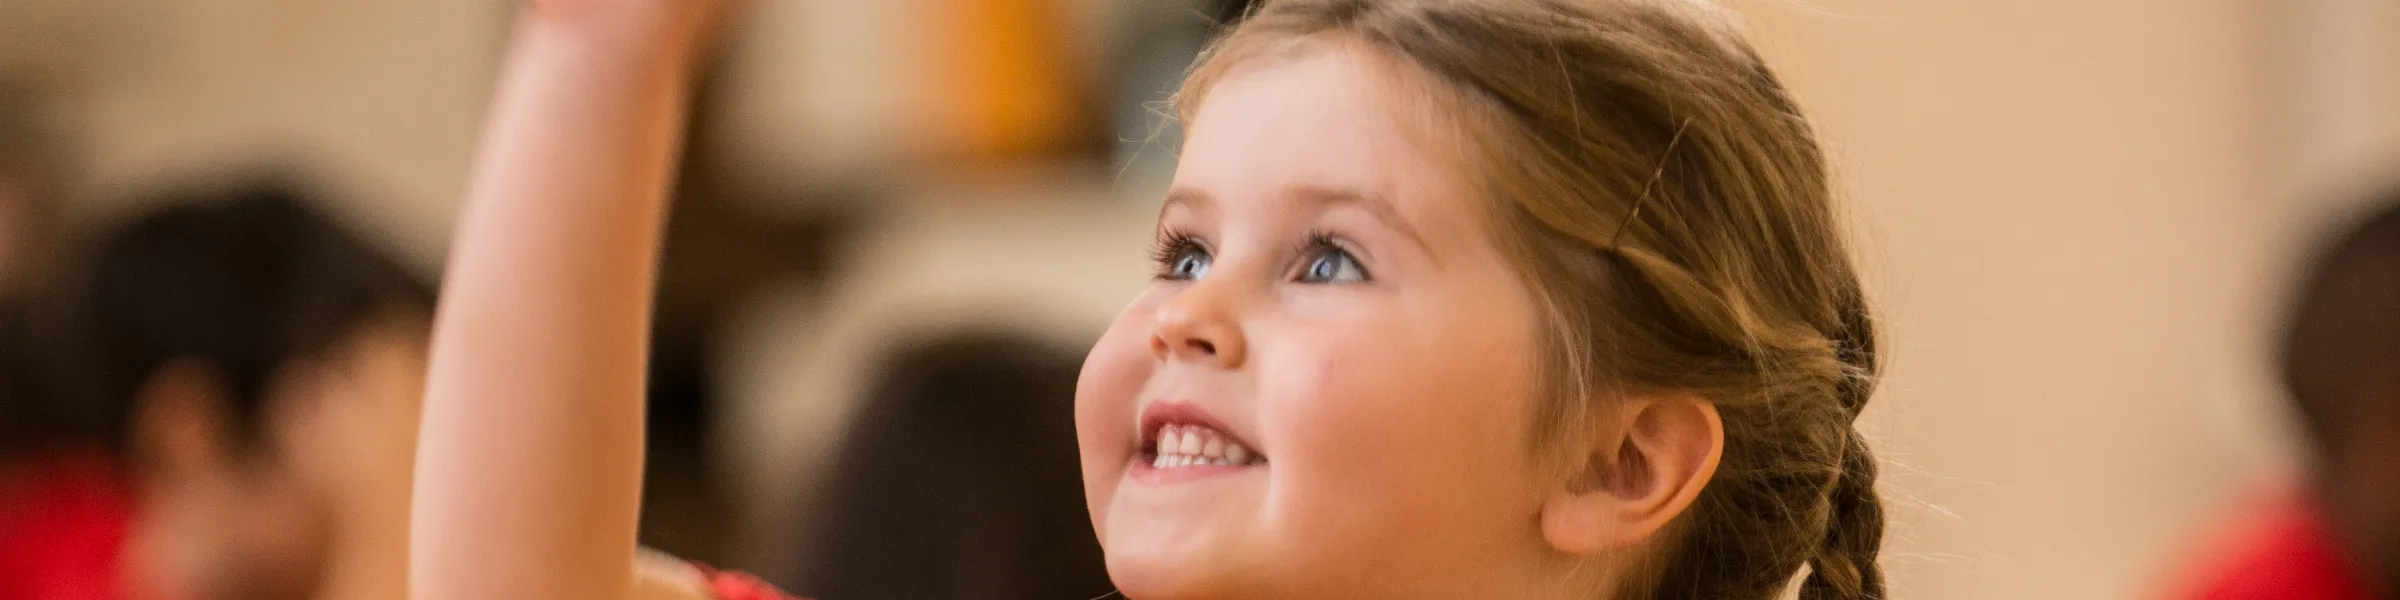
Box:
79 182 432 600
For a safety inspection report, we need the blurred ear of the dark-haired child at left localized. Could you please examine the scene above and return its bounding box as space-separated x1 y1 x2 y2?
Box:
132 360 233 485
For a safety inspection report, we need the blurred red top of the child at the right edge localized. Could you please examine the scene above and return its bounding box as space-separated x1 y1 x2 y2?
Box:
2170 492 2376 600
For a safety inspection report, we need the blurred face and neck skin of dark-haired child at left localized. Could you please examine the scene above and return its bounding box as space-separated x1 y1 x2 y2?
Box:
132 322 425 600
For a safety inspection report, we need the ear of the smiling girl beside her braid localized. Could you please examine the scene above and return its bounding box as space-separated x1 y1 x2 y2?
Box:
1541 394 1726 554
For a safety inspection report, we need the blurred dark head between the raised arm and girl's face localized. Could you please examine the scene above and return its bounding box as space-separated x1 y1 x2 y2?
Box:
790 331 1114 600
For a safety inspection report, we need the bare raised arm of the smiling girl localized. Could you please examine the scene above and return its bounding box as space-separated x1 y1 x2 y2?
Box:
408 0 722 600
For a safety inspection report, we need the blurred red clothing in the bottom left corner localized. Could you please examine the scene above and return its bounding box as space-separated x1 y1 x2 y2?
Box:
0 451 132 600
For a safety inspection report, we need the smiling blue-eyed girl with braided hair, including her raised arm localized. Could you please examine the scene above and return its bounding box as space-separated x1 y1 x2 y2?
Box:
410 0 1884 600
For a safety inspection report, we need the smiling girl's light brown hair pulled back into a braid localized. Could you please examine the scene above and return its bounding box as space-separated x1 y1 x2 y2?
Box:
1176 0 1884 600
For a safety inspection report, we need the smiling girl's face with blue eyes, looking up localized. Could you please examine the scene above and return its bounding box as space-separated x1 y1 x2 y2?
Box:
1075 46 1553 600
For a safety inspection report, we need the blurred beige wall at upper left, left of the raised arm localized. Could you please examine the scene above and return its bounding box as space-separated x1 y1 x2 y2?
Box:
0 0 514 271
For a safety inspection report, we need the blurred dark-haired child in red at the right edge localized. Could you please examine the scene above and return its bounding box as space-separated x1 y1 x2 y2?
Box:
2172 190 2400 600
